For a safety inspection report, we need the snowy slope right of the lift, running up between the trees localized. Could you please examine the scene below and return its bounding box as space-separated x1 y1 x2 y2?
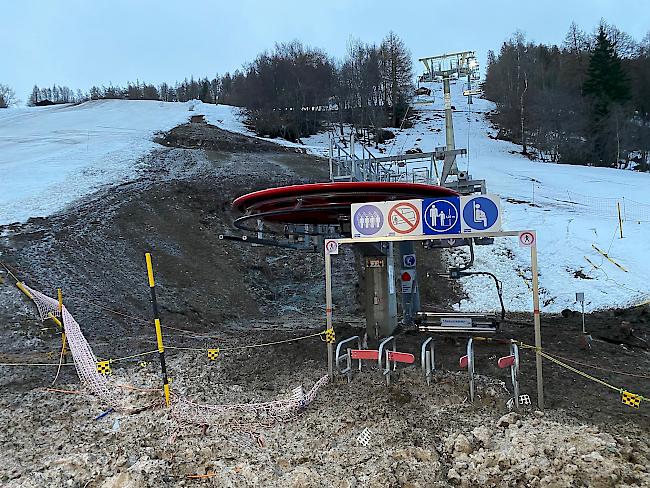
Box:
304 82 650 312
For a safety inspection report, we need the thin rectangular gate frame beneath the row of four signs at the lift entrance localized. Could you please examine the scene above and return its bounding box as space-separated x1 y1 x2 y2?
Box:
324 231 544 410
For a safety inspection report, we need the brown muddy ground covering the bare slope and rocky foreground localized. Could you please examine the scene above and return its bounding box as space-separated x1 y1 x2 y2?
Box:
0 119 650 488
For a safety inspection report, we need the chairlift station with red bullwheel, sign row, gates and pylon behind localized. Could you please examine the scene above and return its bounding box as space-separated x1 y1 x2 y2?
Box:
221 51 543 408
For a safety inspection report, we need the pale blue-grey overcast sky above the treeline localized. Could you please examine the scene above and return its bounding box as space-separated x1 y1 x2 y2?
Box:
0 0 650 102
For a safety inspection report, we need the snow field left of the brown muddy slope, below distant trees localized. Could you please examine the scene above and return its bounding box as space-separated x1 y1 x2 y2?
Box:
0 100 245 224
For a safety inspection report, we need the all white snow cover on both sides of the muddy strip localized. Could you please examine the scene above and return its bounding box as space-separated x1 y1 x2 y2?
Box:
0 90 650 312
